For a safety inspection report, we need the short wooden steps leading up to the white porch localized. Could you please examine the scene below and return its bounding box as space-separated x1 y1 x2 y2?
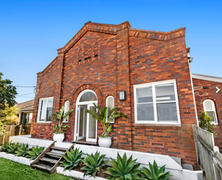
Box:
31 142 74 173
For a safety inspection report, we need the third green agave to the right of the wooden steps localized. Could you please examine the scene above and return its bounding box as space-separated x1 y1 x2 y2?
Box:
105 153 141 180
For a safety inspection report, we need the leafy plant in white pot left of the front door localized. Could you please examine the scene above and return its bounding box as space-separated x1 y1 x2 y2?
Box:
52 106 73 142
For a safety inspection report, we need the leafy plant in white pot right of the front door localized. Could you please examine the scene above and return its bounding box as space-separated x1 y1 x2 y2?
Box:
86 103 128 147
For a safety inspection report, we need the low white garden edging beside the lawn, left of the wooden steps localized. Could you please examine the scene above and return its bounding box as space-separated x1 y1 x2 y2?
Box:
0 152 33 166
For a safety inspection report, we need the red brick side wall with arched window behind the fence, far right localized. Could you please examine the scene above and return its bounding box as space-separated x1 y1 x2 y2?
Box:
193 78 222 151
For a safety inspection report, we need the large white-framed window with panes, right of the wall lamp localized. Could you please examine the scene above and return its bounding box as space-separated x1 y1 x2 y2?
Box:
134 80 180 124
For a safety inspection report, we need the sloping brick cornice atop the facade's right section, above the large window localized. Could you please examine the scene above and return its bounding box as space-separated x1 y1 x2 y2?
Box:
129 28 186 41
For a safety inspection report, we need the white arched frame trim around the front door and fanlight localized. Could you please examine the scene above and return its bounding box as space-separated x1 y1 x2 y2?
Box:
74 89 98 142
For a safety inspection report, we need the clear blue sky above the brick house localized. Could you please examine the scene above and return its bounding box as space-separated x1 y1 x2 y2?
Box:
0 0 222 103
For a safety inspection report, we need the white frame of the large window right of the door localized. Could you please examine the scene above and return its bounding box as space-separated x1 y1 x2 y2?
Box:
133 79 181 125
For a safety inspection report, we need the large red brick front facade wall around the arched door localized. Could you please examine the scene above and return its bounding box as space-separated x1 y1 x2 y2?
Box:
32 22 196 166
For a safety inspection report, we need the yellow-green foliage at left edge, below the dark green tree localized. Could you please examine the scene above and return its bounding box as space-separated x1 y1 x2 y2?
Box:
0 102 20 125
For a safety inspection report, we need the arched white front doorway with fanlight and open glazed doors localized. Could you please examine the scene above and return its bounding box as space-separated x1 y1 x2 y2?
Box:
74 89 98 142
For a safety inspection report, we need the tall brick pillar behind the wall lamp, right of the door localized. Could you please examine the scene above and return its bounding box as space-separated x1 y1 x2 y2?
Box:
117 22 132 150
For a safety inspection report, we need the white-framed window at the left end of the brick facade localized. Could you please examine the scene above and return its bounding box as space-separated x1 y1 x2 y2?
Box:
38 97 53 122
